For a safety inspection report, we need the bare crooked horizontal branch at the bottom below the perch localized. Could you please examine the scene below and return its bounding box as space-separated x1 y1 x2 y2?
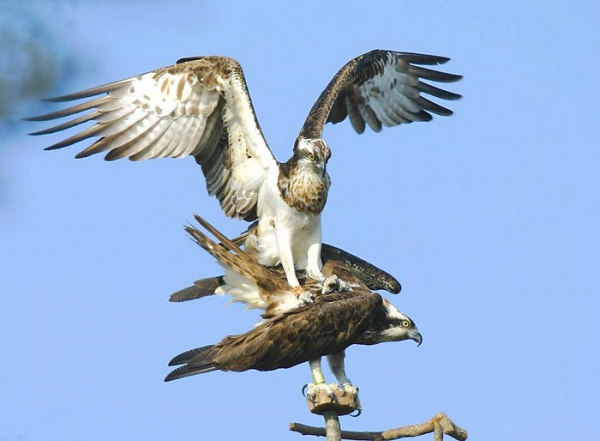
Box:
290 412 469 441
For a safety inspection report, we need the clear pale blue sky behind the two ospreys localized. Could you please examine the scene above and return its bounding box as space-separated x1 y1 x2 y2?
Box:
0 0 600 441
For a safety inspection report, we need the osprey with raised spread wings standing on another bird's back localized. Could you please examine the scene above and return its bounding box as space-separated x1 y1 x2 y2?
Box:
29 50 461 300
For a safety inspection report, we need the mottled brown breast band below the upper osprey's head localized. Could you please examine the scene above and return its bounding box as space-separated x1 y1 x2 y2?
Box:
277 156 331 215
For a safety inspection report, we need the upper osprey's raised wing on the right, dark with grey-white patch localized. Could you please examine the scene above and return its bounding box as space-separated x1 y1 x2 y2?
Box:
300 50 462 138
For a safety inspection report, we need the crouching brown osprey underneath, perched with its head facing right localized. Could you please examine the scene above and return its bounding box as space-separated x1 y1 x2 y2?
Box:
165 216 422 387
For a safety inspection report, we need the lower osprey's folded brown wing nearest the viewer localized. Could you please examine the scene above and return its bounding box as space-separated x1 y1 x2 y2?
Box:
167 291 383 380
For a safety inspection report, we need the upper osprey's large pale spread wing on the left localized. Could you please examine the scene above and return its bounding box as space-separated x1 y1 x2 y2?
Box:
28 56 277 220
